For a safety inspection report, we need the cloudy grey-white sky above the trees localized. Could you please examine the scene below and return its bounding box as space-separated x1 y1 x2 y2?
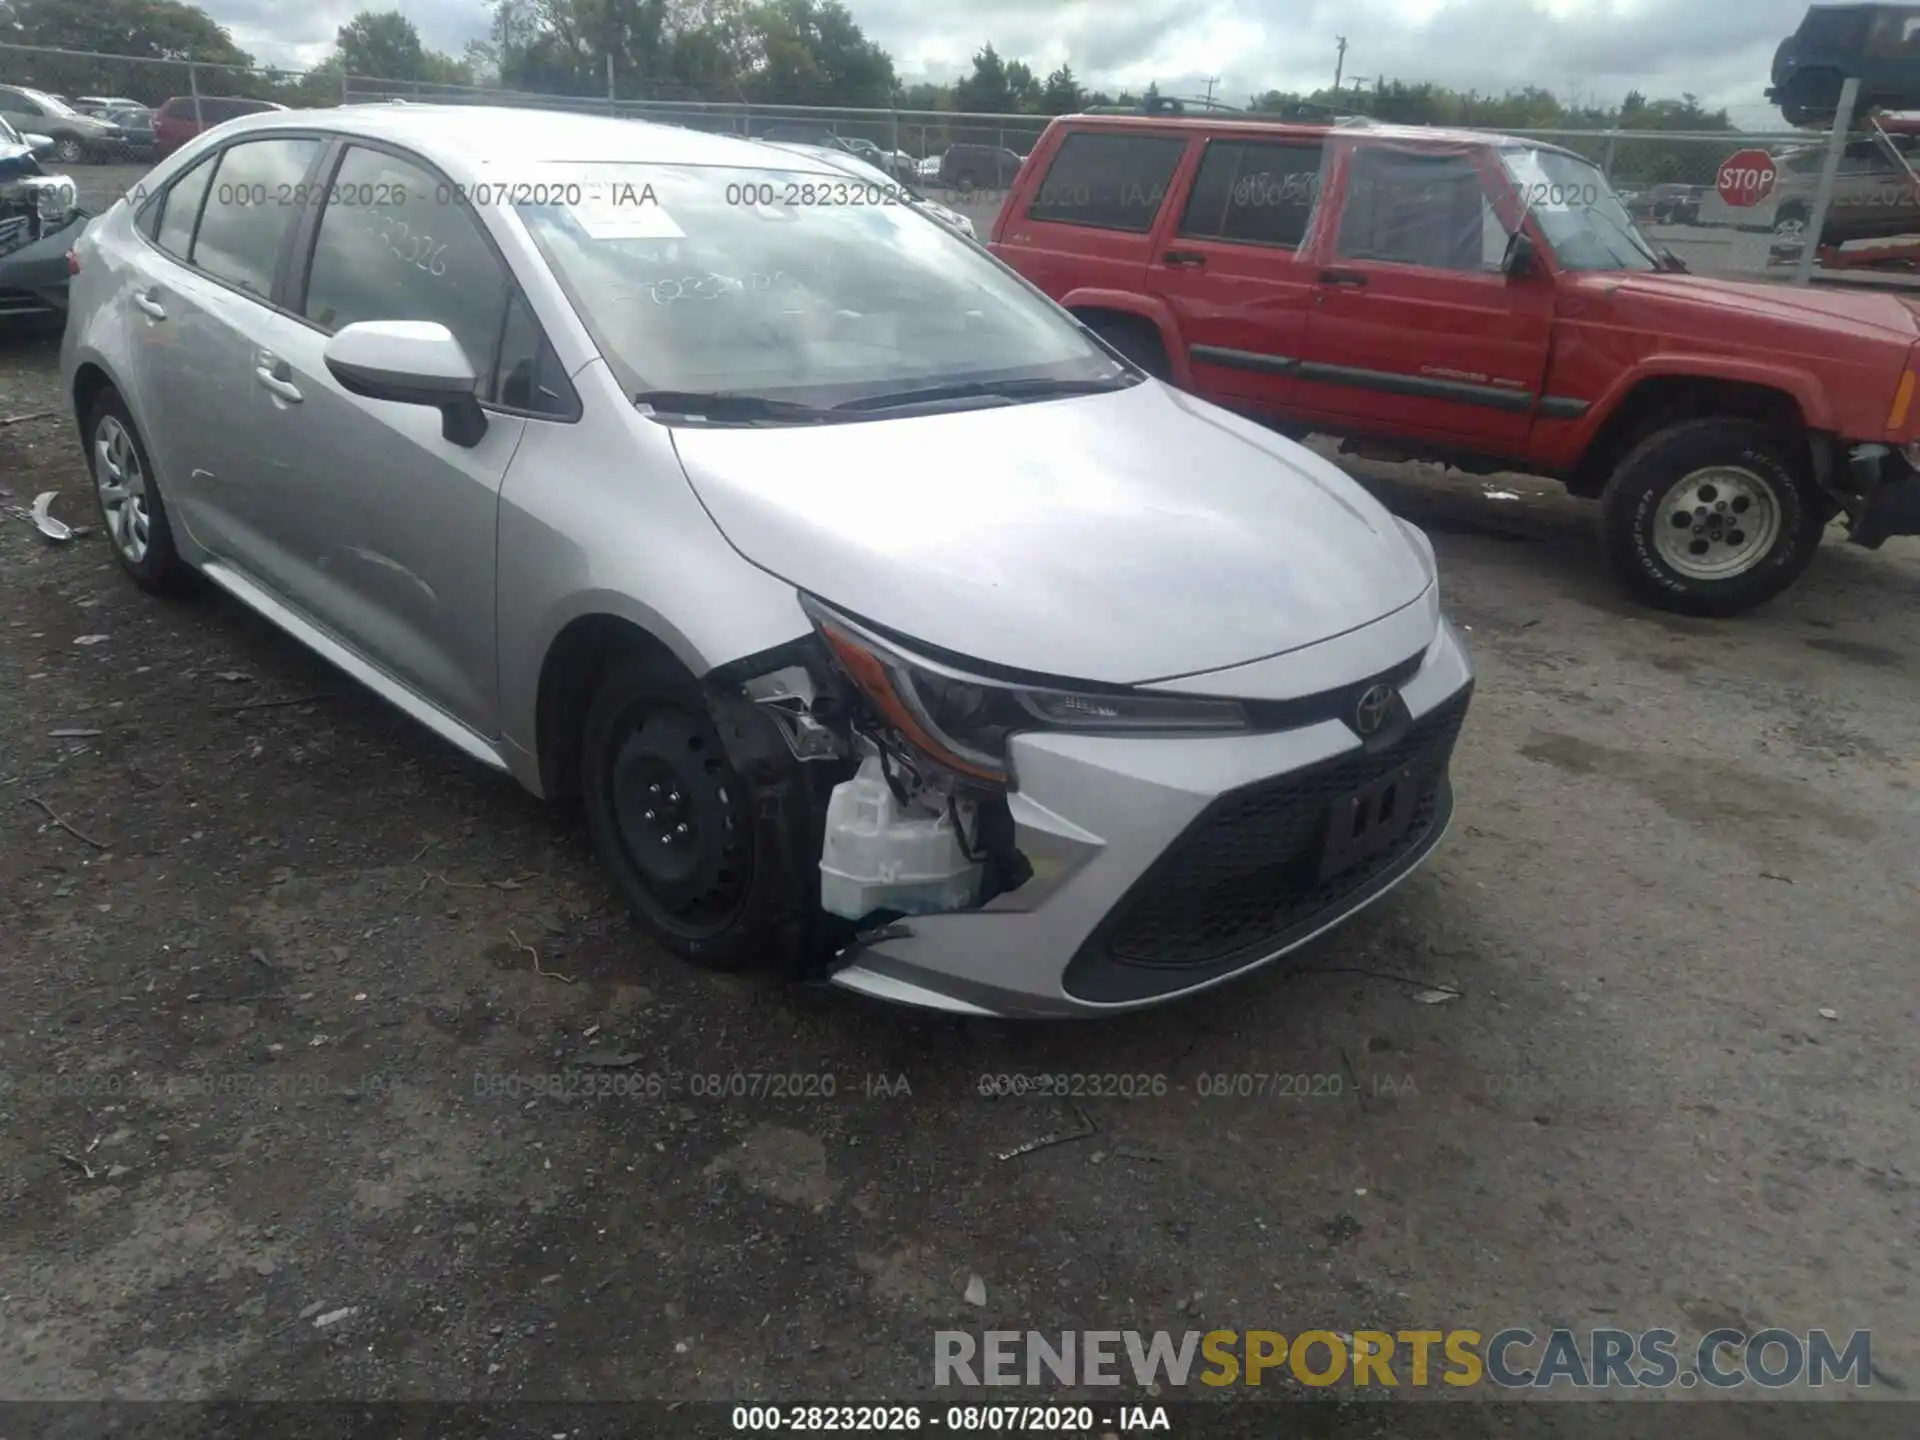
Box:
202 0 1807 125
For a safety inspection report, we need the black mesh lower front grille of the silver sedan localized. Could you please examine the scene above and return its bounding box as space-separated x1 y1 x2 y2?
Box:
1066 691 1469 1002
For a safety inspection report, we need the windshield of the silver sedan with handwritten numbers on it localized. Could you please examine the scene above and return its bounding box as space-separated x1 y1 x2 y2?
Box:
513 165 1129 405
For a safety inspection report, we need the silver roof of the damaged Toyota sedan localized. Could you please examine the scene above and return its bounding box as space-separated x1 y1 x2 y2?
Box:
200 102 848 175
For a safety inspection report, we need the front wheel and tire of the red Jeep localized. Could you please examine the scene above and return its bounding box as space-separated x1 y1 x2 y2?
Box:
1601 419 1832 616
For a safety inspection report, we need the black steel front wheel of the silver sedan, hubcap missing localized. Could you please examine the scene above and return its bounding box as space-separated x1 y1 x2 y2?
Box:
580 655 818 970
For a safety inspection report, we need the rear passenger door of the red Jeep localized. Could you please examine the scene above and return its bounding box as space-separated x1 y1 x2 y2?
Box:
1146 134 1327 422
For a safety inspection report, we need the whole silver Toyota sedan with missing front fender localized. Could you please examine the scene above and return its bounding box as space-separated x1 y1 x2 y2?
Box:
63 106 1471 1016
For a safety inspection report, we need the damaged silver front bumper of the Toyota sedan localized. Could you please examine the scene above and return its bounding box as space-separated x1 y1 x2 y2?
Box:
828 622 1473 1016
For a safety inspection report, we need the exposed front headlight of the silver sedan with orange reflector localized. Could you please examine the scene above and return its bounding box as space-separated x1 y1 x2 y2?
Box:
801 595 1248 785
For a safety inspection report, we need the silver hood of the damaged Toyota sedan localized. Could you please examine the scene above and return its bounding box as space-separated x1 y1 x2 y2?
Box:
674 380 1432 684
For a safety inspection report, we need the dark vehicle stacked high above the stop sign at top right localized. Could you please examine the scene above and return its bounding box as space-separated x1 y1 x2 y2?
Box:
1766 6 1920 125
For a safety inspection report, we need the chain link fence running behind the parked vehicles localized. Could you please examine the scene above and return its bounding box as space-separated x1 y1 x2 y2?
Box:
0 44 1920 284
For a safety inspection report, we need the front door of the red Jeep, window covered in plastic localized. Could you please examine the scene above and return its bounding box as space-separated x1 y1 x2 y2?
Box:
1296 140 1553 455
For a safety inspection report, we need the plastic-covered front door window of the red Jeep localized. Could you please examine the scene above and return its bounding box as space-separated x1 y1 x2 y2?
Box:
1336 146 1505 271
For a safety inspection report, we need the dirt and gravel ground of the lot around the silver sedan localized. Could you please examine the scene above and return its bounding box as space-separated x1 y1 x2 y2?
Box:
0 166 1920 1434
